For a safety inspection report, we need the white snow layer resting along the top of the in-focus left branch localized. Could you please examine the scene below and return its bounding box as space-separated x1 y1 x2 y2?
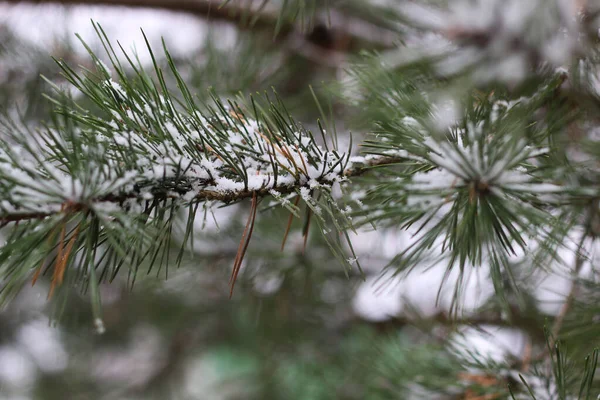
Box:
0 96 404 223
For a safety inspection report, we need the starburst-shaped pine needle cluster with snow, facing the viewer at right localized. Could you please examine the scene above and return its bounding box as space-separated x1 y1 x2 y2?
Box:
346 54 598 312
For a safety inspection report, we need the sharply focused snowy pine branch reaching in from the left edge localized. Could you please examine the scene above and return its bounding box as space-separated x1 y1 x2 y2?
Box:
0 30 412 308
